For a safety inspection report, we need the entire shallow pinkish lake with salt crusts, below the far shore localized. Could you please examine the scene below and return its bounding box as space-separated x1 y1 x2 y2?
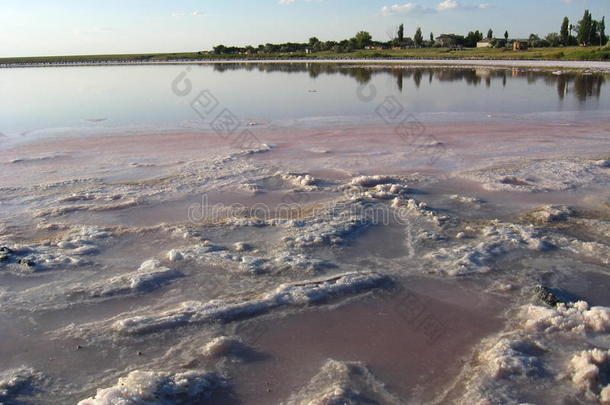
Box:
0 65 610 405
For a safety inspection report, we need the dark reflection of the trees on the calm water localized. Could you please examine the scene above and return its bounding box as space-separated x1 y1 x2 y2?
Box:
214 63 606 102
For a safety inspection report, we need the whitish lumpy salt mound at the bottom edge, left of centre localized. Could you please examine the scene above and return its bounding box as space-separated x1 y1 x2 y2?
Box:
78 370 226 405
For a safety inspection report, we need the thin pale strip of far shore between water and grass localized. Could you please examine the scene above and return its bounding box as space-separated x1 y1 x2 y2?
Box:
0 58 610 73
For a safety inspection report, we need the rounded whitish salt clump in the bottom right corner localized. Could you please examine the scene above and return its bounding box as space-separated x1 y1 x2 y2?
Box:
570 349 610 405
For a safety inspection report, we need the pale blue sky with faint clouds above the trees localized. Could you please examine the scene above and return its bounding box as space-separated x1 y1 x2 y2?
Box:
0 0 610 56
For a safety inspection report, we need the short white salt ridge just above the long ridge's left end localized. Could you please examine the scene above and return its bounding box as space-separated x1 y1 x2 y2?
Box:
69 260 182 298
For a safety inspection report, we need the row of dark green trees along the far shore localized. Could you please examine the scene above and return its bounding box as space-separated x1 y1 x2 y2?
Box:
213 10 608 54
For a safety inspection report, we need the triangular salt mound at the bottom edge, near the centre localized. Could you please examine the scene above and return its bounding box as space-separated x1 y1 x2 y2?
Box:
280 359 405 405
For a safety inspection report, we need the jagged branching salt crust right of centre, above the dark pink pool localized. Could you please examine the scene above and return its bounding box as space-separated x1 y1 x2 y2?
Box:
424 223 552 276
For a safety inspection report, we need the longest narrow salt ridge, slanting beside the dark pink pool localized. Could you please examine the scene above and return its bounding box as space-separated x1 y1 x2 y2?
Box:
112 272 389 335
